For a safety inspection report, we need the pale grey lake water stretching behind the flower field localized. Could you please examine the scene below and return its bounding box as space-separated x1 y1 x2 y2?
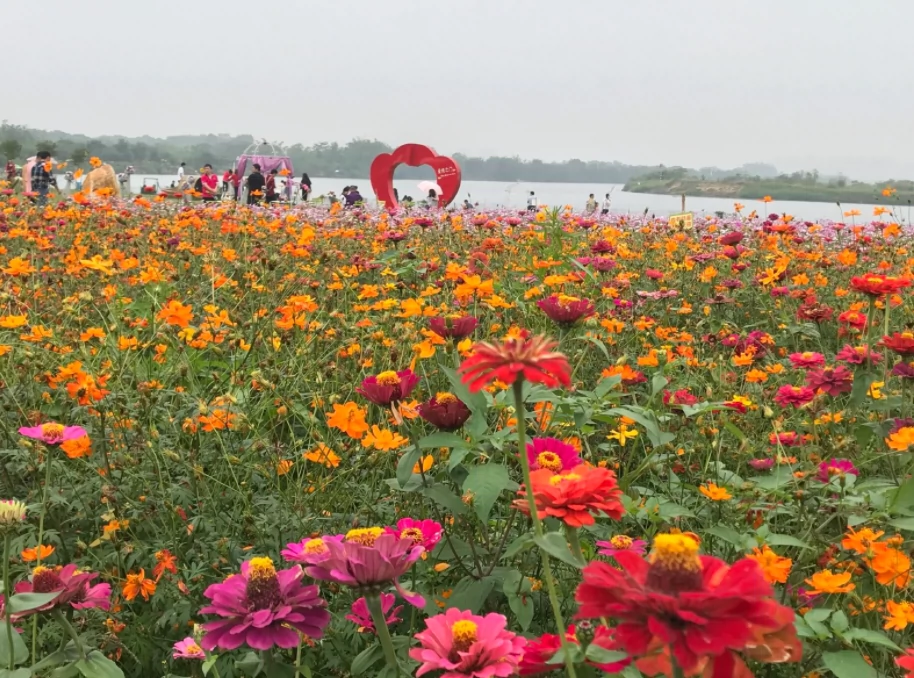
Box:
119 174 911 223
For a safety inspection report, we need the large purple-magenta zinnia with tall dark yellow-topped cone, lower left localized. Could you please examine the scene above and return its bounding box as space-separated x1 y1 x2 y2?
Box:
200 558 330 650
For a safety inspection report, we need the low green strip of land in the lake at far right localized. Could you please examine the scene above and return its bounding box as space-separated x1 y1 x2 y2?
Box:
623 167 914 206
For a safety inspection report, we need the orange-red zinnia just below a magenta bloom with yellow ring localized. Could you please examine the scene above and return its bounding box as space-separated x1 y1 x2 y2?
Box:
514 465 625 527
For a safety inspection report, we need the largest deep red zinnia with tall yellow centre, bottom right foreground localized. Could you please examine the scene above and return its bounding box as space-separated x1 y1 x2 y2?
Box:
575 534 802 676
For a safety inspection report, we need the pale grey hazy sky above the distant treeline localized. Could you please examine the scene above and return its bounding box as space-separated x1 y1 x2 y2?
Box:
7 0 914 179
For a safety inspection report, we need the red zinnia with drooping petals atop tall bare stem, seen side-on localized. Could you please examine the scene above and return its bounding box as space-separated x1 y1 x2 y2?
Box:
458 334 571 393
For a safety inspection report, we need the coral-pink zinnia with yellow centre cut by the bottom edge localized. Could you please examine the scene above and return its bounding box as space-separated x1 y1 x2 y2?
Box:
409 607 527 678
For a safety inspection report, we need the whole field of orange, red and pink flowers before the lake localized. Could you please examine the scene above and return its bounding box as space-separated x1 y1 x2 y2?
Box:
0 191 914 678
